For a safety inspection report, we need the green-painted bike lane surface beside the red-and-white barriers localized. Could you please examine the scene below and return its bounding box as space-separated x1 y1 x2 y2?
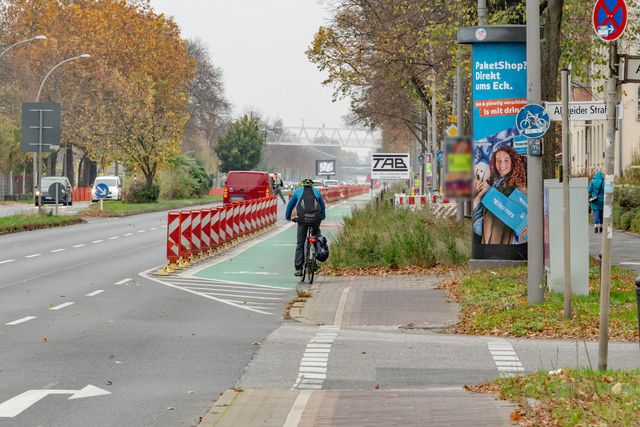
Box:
192 194 370 289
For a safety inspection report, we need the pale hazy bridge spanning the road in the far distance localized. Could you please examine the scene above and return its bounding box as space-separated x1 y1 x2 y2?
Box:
265 126 382 149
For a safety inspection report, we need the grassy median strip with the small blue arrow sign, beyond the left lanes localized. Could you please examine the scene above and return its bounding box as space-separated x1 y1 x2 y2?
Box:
81 196 222 217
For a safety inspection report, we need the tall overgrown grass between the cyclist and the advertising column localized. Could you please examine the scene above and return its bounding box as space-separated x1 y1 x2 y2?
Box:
327 204 471 271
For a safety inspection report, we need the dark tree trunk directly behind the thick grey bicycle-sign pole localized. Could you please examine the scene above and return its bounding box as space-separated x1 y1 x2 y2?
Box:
541 0 564 179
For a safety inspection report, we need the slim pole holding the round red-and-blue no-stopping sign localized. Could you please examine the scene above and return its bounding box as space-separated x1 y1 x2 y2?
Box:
598 42 620 371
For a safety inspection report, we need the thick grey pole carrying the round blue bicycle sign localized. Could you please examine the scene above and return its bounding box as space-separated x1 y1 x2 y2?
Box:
527 0 544 304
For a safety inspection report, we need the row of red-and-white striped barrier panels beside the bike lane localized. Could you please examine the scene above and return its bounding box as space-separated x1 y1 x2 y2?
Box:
155 196 278 276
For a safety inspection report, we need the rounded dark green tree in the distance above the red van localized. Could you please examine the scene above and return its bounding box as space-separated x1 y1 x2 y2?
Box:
215 115 265 172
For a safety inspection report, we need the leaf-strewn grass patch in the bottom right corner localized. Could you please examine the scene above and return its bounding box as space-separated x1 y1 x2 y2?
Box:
496 369 640 427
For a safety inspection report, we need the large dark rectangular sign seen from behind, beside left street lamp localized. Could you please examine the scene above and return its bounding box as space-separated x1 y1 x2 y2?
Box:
20 102 62 153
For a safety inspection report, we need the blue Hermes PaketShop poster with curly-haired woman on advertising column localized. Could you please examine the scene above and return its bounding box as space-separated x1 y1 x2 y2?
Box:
472 43 528 260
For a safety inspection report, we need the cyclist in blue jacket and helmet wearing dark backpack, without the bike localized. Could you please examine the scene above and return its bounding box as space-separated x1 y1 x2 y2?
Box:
285 179 326 276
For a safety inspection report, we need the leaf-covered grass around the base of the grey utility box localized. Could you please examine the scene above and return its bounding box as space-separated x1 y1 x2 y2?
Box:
443 265 638 340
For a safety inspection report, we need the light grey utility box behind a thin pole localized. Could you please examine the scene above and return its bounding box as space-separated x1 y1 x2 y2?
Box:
544 178 590 295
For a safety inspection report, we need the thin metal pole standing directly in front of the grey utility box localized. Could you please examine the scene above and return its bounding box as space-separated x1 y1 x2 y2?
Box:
560 70 571 319
